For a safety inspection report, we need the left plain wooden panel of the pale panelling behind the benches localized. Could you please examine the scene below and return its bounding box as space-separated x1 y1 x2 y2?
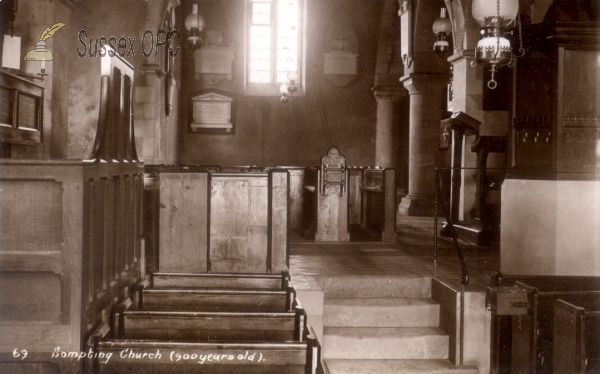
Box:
159 173 209 273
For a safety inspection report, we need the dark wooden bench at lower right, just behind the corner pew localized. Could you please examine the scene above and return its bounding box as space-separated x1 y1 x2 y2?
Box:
492 276 600 373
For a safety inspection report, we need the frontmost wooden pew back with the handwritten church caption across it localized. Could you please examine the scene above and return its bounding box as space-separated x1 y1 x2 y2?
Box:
90 338 322 374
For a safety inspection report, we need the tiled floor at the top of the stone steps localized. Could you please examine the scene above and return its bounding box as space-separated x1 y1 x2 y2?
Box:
290 216 500 291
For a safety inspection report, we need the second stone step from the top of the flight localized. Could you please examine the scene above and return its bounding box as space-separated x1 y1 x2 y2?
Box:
323 297 440 327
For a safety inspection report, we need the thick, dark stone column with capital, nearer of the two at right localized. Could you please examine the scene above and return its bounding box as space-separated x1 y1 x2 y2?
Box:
398 74 450 216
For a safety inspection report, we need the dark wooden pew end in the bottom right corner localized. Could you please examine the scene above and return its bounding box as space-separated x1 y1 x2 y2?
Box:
553 299 600 374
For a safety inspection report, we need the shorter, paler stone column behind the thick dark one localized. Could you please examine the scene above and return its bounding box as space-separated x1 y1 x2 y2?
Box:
373 87 406 168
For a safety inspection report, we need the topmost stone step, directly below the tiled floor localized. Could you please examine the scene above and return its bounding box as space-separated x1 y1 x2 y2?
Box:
314 275 431 298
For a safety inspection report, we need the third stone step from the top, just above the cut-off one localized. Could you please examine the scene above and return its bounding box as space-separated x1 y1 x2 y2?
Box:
322 327 449 359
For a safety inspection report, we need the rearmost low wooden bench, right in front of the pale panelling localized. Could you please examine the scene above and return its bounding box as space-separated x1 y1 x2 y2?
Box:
152 271 290 290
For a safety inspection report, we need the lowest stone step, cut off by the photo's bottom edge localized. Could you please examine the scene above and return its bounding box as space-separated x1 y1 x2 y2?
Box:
325 359 479 374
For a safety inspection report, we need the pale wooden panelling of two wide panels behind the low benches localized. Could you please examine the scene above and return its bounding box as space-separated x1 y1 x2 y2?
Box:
152 167 289 274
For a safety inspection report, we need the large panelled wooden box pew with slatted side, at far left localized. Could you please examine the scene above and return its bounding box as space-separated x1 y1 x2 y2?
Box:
0 160 144 373
